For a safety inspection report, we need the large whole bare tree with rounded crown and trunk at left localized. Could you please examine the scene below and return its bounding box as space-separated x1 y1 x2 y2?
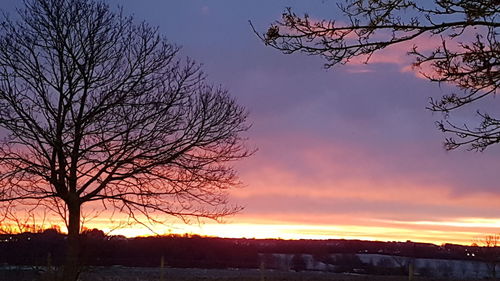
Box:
0 0 251 280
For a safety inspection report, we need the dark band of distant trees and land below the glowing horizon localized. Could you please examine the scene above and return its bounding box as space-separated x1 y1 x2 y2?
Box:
0 230 492 271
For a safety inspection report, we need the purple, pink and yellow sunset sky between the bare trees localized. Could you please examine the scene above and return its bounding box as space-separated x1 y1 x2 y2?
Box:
0 0 500 244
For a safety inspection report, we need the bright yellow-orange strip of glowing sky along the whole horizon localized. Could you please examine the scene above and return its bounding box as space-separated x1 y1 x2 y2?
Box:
2 212 500 245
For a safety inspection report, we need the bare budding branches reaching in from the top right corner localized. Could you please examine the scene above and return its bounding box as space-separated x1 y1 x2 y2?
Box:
252 0 500 151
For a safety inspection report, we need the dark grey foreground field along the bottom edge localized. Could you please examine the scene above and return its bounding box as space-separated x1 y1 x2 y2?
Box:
0 267 484 281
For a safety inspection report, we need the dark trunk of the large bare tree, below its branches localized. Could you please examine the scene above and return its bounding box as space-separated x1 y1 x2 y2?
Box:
63 199 80 281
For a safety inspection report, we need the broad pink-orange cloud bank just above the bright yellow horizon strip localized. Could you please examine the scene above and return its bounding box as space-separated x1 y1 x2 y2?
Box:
231 130 500 231
